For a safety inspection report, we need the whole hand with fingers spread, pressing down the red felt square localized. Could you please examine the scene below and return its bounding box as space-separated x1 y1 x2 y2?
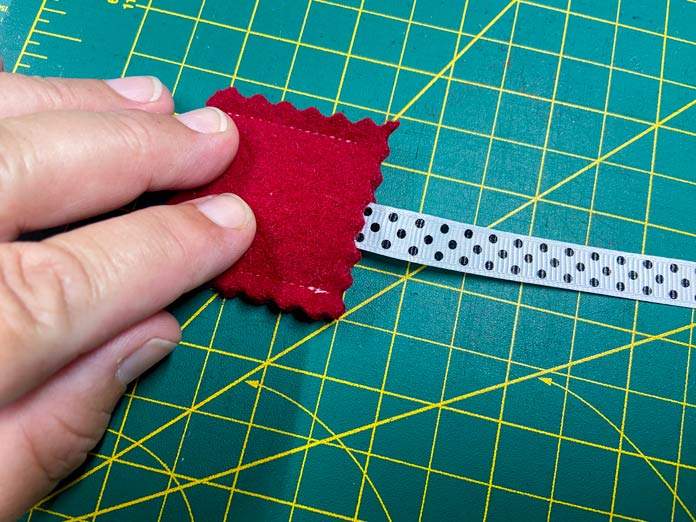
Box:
0 62 255 520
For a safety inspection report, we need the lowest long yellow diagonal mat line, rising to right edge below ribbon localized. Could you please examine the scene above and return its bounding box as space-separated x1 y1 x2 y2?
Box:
66 323 696 515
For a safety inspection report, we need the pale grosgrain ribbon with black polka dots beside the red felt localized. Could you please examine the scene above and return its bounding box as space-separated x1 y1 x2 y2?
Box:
355 204 696 308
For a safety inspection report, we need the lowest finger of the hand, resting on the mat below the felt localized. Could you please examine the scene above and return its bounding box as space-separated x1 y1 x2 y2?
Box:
0 312 181 520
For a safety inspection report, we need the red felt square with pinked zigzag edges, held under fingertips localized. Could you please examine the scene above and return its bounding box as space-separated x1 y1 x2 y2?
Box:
173 89 398 319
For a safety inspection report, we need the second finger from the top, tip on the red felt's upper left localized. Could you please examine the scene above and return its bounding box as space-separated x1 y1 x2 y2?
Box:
0 107 239 241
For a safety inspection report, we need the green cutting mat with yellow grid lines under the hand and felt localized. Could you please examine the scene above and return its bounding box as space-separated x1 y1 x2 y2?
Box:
0 0 696 522
